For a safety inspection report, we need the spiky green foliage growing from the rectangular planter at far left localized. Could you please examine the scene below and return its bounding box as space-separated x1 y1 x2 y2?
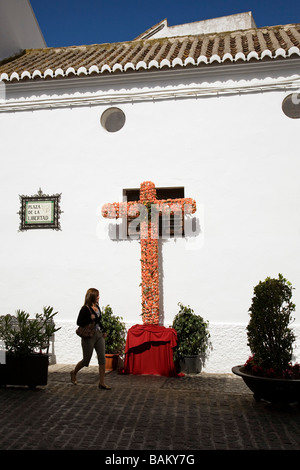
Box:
0 307 60 356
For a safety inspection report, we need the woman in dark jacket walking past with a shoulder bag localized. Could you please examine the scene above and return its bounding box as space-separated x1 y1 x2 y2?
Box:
71 288 111 390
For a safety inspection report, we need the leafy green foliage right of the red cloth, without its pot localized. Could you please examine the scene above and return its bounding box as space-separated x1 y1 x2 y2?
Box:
172 302 211 362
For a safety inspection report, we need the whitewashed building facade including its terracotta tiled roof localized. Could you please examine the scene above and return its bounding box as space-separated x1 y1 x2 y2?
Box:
0 2 300 373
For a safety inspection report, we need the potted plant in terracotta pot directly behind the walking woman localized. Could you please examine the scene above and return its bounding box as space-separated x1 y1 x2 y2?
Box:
101 305 127 370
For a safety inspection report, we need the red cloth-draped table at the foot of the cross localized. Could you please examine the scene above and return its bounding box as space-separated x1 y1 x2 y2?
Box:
124 324 177 377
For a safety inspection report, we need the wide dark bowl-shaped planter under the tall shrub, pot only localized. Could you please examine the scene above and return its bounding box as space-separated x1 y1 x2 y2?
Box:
232 366 300 404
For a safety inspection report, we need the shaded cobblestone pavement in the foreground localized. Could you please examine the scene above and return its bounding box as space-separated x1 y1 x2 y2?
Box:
0 365 300 452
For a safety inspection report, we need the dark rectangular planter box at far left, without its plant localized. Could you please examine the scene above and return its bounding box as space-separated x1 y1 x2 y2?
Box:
0 354 49 388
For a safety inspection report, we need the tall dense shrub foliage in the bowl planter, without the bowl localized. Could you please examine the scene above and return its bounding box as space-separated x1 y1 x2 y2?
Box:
246 274 295 375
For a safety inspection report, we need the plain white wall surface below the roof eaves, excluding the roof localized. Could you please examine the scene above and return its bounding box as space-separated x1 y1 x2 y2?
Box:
0 61 300 372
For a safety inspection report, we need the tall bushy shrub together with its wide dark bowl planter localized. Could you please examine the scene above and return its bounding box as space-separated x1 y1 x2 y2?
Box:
232 274 300 403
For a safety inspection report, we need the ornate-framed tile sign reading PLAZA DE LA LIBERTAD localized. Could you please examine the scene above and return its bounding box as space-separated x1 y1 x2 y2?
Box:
19 190 61 231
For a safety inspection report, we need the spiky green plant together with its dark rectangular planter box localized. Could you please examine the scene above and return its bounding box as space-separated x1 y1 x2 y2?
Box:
0 307 60 388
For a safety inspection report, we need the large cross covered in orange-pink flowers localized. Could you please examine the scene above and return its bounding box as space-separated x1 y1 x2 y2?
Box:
102 181 196 324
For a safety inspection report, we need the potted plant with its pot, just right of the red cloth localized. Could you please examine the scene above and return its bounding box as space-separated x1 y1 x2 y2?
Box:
172 302 211 374
